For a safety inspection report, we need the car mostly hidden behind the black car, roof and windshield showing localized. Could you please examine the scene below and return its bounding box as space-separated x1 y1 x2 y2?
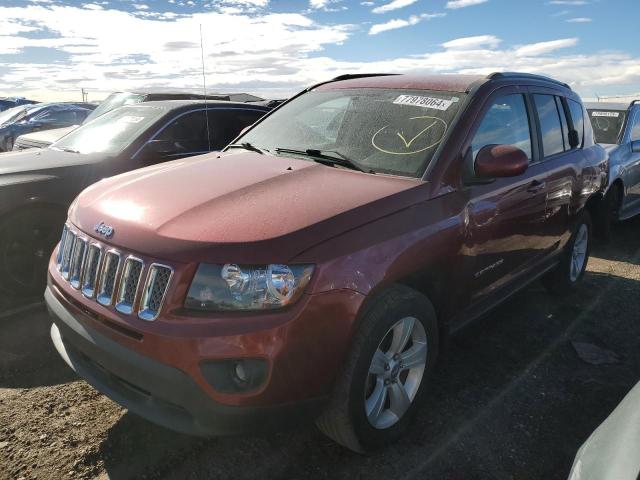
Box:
13 90 268 150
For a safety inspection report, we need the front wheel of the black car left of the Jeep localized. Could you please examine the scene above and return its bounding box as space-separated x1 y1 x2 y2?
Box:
0 206 66 298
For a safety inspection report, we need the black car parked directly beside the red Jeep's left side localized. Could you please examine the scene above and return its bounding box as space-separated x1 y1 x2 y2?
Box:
0 100 269 295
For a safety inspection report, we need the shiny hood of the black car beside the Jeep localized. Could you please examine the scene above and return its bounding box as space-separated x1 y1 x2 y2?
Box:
0 148 105 175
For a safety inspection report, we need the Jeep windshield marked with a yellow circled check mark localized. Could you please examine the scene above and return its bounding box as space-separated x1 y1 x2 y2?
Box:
239 88 464 177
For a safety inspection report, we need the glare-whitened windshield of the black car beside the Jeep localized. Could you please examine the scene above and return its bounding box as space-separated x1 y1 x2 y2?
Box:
51 105 166 154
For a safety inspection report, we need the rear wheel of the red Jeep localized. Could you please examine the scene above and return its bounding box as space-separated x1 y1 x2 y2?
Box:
542 211 592 295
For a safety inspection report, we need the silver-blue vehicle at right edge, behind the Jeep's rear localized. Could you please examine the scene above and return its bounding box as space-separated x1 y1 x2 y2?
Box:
585 100 640 237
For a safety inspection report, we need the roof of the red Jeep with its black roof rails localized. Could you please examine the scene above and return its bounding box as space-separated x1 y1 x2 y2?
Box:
317 72 571 93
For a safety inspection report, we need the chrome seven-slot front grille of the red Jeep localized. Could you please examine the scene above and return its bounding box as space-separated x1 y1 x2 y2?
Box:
56 224 173 321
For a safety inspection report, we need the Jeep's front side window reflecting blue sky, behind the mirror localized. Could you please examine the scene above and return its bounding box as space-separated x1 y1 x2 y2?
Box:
471 94 531 160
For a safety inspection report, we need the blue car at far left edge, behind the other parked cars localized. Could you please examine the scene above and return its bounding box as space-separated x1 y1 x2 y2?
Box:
0 103 96 152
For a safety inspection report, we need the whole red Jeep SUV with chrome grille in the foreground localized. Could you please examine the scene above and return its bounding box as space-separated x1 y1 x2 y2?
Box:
45 73 607 451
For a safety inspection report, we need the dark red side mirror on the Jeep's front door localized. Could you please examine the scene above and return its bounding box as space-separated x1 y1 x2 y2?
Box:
474 145 529 178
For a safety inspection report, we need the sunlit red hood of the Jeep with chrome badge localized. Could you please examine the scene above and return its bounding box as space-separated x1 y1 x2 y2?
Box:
70 152 427 263
